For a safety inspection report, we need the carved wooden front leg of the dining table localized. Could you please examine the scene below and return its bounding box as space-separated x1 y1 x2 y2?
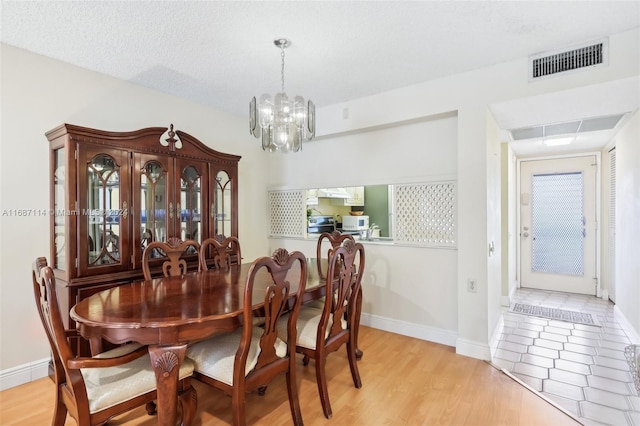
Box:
149 344 187 426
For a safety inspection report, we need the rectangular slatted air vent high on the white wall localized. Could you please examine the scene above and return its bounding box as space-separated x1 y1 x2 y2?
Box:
529 39 609 80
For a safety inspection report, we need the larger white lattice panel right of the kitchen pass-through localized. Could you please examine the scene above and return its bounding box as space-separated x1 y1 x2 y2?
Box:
393 182 457 248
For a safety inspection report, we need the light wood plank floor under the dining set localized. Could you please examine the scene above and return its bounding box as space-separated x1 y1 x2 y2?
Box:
0 327 579 426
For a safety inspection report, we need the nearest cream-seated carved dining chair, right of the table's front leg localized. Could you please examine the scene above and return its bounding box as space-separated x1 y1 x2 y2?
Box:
187 249 307 425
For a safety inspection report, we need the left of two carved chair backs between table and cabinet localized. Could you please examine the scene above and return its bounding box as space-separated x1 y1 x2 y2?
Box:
142 237 200 280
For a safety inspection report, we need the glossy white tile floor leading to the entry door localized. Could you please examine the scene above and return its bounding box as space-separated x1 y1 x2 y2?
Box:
492 289 640 426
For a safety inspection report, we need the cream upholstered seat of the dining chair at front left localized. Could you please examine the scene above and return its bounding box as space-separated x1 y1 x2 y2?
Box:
80 343 194 413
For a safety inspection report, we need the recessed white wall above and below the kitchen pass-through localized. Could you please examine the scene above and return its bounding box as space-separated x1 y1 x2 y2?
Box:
270 114 458 346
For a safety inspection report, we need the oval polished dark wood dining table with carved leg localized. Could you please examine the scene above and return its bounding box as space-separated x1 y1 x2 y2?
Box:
70 259 359 426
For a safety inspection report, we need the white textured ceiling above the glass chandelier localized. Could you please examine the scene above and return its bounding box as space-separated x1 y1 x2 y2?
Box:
0 0 640 155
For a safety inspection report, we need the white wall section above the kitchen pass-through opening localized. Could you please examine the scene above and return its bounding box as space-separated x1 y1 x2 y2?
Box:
270 114 458 188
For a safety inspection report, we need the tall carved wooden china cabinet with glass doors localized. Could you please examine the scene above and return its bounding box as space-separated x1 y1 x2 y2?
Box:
46 124 240 355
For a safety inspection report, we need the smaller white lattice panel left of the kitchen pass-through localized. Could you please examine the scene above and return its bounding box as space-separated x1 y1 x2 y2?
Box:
269 190 307 237
